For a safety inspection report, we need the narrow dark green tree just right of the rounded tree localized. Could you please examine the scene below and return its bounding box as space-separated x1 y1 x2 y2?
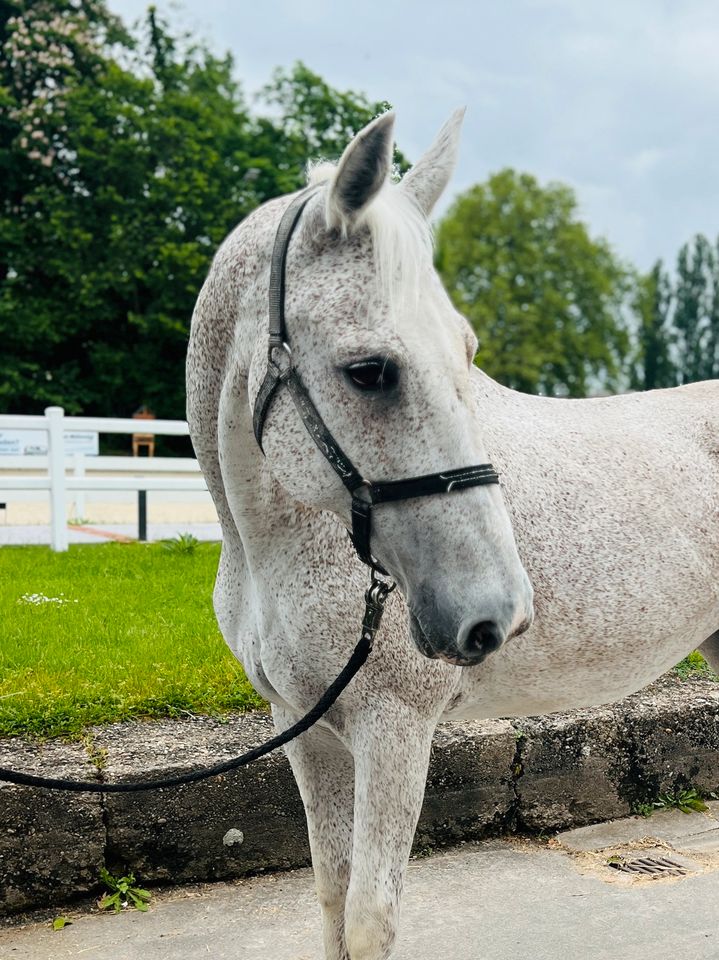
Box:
631 260 677 390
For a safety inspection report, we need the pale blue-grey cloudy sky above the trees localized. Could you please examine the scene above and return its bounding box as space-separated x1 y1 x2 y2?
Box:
110 0 719 268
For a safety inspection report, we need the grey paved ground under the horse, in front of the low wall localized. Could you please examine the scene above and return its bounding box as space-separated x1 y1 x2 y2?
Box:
0 808 719 960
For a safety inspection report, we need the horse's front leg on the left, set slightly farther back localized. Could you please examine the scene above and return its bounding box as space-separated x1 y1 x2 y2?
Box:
272 706 354 960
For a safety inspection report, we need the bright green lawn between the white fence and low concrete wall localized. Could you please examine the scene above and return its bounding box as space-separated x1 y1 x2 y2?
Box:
0 543 263 738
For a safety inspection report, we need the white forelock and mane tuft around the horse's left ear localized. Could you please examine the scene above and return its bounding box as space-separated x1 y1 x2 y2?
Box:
307 161 433 318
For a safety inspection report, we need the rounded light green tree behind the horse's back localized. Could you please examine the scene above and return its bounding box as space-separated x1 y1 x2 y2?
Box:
437 170 629 397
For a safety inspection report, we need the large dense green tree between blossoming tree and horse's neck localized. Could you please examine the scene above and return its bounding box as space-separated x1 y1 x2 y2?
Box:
0 2 256 416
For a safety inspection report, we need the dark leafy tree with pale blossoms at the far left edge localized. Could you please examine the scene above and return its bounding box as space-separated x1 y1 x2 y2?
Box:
0 0 128 410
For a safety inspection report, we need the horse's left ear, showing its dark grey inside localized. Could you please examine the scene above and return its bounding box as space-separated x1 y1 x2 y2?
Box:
326 112 394 233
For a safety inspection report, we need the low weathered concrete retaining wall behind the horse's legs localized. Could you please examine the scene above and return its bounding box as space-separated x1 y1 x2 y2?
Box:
0 678 719 914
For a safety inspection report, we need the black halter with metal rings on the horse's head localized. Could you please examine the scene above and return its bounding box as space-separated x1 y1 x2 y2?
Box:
253 188 499 572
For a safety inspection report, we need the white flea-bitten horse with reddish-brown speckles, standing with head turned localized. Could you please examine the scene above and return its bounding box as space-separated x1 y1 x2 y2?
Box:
188 113 719 960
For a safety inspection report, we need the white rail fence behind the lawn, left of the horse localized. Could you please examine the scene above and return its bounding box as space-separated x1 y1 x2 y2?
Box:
0 407 207 550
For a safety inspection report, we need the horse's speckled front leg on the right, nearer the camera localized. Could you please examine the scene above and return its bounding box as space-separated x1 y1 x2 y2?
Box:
345 704 435 960
